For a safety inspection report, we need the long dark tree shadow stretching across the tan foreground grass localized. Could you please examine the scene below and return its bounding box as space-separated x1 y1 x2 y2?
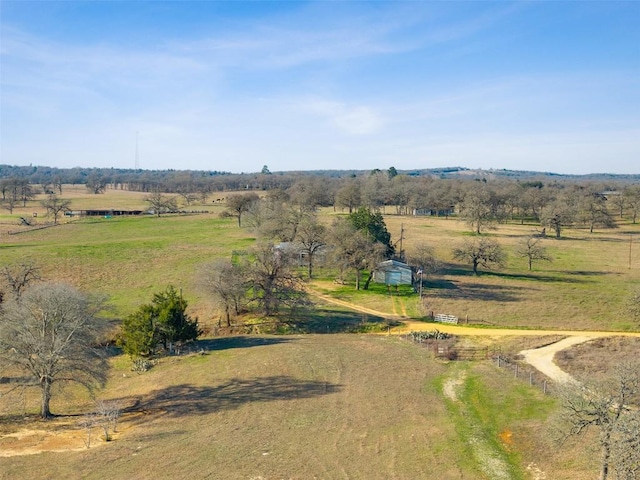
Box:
123 375 342 417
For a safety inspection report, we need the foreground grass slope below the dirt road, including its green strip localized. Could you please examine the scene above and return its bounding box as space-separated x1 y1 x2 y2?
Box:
0 334 589 480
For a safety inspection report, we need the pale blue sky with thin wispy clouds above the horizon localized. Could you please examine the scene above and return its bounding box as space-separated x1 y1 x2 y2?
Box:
0 0 640 174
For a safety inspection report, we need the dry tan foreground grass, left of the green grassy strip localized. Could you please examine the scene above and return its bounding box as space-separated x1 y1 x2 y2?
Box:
0 335 460 479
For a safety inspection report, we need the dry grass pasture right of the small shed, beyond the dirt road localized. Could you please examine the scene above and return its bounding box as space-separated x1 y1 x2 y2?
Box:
385 216 640 330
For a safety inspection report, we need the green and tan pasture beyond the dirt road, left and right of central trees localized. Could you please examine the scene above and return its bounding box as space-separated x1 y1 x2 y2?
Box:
0 186 640 330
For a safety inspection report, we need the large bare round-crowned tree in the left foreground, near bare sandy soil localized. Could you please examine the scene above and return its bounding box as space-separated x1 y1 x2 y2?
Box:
0 283 107 418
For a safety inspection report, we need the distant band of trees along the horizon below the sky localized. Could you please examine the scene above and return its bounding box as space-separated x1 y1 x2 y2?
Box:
0 165 640 227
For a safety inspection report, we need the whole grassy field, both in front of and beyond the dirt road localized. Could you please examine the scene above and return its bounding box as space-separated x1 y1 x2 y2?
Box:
0 186 640 480
